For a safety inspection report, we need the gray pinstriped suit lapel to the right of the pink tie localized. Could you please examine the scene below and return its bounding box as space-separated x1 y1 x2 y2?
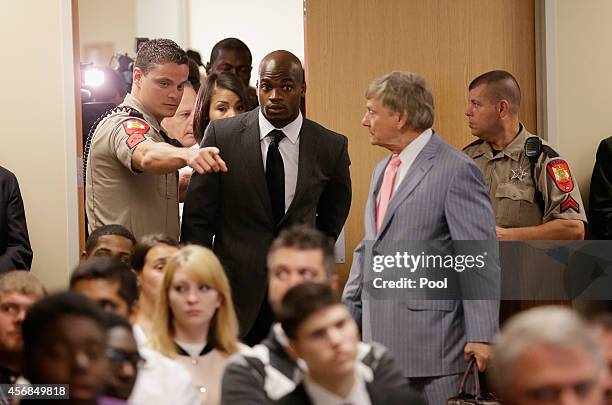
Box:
377 132 442 237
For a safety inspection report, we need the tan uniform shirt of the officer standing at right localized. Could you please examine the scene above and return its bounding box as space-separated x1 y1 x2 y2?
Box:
463 124 586 228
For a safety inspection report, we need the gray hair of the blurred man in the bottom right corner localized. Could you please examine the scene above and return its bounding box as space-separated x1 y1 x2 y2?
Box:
488 306 605 393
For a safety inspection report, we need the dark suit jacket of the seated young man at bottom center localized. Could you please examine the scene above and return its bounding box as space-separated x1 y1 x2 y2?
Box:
274 383 425 405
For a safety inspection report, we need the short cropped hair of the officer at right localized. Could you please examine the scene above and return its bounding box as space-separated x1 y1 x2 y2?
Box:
469 70 521 114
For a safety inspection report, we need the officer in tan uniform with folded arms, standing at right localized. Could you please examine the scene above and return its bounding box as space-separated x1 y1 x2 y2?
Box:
464 71 586 240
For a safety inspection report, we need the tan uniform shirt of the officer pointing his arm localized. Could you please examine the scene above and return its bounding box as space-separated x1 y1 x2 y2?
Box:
85 94 179 239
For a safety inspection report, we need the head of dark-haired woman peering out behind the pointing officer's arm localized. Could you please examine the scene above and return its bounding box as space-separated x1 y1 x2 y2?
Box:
193 73 251 143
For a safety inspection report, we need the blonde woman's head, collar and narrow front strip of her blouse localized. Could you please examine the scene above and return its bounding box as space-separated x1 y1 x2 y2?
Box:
150 246 240 404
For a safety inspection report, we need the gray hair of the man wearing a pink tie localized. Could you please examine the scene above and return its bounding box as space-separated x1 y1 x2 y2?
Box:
366 72 435 130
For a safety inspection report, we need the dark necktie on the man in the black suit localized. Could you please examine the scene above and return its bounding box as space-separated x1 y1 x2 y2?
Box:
266 129 285 225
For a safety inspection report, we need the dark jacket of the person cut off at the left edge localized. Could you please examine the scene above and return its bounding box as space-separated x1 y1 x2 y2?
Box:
0 166 32 273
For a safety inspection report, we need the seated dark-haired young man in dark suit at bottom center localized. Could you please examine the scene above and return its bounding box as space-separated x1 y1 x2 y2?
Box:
277 283 424 405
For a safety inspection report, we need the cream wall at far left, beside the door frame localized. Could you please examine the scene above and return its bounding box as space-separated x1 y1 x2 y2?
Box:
0 0 79 289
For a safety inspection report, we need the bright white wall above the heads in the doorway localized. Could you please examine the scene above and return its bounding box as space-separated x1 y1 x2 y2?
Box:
188 0 304 84
